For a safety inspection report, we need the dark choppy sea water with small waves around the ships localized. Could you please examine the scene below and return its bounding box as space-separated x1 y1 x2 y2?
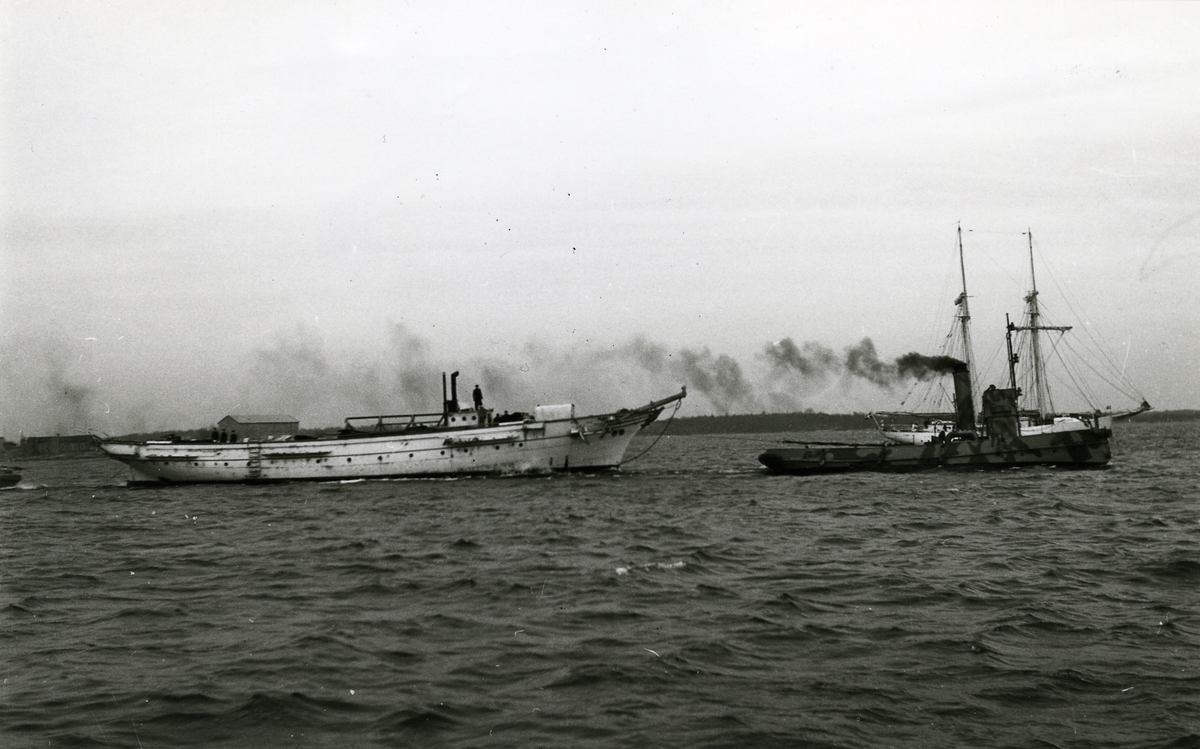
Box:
0 424 1200 749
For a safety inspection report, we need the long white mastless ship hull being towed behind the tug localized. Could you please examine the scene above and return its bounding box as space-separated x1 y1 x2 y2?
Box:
97 372 688 484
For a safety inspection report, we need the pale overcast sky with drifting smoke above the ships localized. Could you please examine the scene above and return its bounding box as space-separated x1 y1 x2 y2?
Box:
0 0 1200 439
